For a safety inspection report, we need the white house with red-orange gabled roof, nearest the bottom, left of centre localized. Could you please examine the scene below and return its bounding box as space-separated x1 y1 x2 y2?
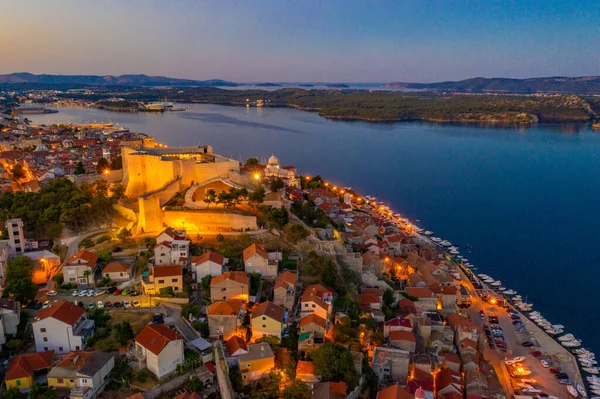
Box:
131 324 183 380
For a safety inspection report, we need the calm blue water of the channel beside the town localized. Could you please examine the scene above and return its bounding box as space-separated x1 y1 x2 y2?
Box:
30 105 600 351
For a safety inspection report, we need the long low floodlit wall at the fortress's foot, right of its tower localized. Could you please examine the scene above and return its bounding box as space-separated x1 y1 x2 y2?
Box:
164 211 258 232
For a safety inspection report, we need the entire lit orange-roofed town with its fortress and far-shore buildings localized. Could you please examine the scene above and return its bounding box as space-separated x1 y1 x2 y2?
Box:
0 84 600 399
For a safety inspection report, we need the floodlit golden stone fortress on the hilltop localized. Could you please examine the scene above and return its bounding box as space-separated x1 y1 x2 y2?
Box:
121 146 258 233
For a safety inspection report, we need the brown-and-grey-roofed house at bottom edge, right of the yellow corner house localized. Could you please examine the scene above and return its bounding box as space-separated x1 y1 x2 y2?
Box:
48 351 115 399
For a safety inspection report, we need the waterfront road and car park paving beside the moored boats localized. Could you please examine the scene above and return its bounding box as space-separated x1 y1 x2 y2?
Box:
463 277 581 398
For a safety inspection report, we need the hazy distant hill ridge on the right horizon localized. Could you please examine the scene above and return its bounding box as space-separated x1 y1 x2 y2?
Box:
384 76 600 94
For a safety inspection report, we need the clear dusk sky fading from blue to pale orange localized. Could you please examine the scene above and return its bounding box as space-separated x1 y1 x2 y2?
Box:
0 0 600 82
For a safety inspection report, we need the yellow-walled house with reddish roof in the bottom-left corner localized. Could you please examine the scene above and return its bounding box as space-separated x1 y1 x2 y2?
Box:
4 351 54 391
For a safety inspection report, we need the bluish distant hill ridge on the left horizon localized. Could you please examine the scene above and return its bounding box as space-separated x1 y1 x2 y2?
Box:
0 72 237 87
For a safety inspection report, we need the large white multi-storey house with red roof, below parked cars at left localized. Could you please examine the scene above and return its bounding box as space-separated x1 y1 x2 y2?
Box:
32 301 94 354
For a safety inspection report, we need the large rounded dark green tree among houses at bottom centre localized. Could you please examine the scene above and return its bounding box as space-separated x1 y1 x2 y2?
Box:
312 343 359 390
